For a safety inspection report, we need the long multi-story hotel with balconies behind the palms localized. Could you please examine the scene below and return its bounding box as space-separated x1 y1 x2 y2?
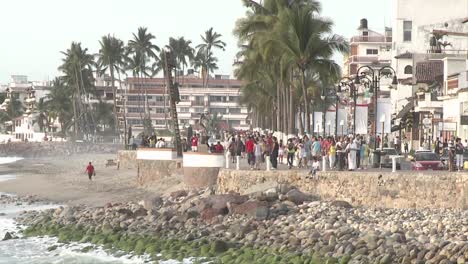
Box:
119 75 250 133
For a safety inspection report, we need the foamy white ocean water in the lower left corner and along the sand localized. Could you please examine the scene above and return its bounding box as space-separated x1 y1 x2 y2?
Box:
0 157 192 264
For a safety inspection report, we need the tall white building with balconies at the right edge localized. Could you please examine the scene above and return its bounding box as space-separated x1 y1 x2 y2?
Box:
391 0 468 145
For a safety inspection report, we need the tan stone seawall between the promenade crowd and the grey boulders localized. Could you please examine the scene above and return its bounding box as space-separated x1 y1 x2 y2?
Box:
217 169 468 209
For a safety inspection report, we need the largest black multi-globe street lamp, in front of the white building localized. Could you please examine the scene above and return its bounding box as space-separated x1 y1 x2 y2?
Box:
354 66 398 150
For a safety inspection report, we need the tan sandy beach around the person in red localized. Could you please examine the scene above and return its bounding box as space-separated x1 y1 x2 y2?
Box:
0 154 183 206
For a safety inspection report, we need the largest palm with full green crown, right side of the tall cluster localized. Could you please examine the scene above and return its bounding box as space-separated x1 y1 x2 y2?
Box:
269 2 349 134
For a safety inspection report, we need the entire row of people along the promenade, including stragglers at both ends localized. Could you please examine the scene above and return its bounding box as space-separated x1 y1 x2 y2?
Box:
129 131 468 174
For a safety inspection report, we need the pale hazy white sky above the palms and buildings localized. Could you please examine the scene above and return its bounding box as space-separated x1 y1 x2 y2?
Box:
0 0 391 84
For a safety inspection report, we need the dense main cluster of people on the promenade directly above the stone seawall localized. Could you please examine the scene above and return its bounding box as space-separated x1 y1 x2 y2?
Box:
210 132 380 174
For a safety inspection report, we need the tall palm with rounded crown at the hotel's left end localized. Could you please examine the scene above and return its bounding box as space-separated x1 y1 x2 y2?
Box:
97 35 125 134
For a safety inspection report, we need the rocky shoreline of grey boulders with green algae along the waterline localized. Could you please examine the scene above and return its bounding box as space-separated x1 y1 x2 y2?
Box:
5 185 468 264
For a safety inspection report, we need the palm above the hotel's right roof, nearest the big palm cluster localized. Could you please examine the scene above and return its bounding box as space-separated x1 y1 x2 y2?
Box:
195 28 226 87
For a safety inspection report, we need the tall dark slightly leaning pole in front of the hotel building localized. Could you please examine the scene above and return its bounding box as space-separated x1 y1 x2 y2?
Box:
164 52 182 157
